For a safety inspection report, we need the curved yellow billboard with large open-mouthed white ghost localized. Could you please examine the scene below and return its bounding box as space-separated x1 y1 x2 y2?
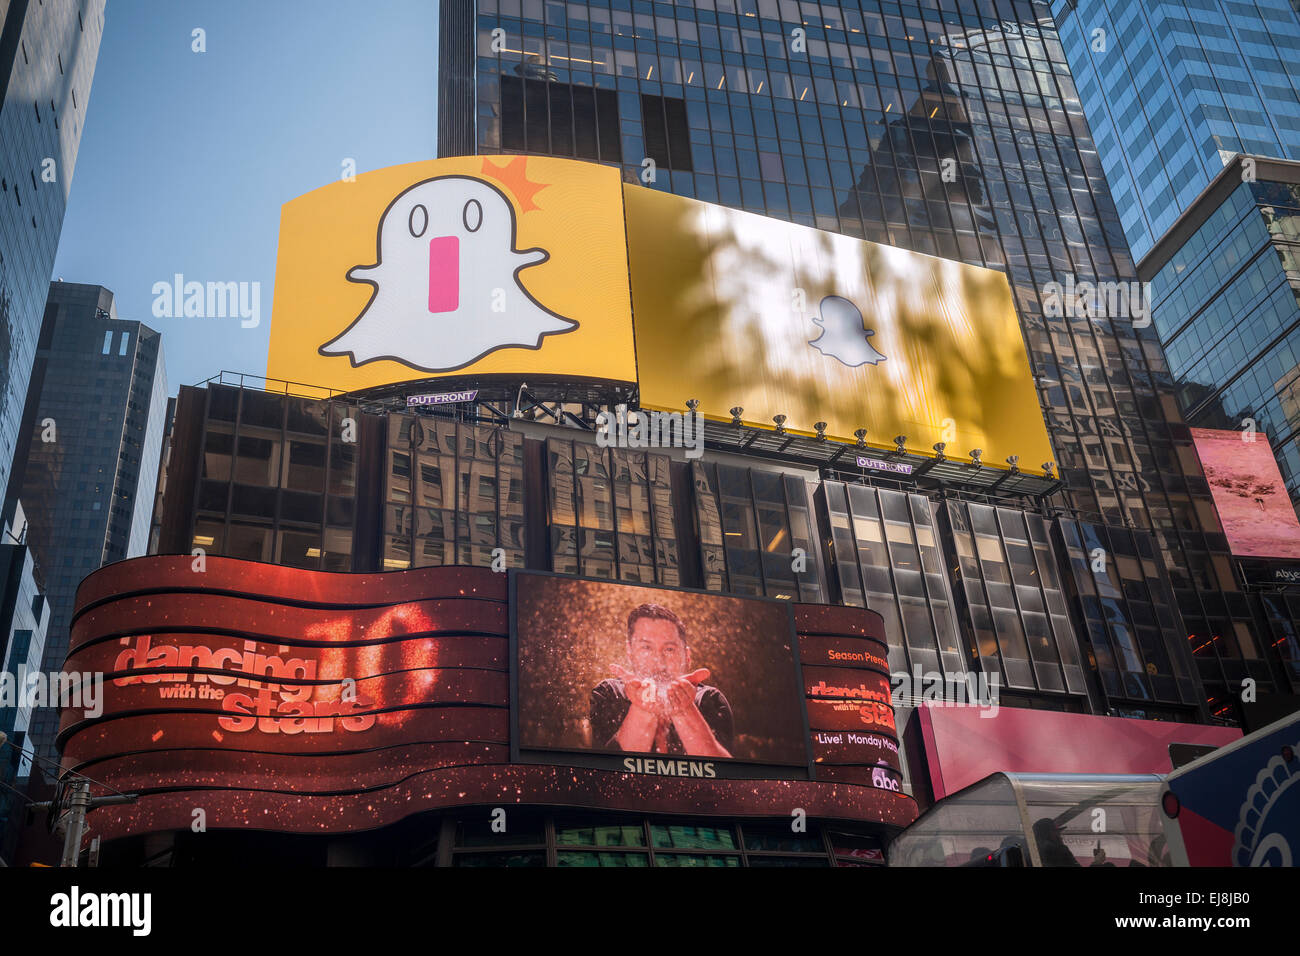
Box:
267 156 636 392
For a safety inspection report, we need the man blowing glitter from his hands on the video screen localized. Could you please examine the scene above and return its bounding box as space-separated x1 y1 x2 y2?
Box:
590 604 733 757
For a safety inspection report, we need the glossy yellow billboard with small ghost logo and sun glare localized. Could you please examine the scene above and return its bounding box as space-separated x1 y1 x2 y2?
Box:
623 185 1053 470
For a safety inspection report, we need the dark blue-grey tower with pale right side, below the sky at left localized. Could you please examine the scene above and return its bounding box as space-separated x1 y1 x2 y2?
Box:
14 282 168 756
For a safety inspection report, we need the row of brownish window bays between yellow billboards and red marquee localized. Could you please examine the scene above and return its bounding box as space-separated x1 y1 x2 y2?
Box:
159 385 1206 719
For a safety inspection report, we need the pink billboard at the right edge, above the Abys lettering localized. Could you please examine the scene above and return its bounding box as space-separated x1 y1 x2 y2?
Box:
1191 428 1300 558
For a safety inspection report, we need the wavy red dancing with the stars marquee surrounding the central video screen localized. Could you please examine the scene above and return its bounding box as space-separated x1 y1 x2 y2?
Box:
59 555 917 839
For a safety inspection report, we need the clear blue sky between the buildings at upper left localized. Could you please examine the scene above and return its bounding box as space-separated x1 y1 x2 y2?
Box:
53 0 438 394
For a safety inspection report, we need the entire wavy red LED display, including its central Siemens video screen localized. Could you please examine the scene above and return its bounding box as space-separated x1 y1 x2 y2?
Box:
59 555 915 839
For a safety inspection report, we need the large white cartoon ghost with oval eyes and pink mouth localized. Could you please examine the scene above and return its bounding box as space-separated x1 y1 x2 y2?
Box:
319 176 579 372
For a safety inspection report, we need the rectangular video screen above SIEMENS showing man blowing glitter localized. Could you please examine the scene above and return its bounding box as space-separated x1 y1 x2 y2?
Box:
514 574 807 775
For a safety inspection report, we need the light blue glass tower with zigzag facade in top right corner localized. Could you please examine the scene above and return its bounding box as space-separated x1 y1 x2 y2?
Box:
1052 0 1300 259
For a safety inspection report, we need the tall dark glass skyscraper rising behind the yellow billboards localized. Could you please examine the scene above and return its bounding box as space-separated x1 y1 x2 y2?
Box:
439 0 1300 715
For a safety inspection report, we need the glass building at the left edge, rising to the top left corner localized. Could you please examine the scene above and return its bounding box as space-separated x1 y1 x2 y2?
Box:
0 0 104 509
